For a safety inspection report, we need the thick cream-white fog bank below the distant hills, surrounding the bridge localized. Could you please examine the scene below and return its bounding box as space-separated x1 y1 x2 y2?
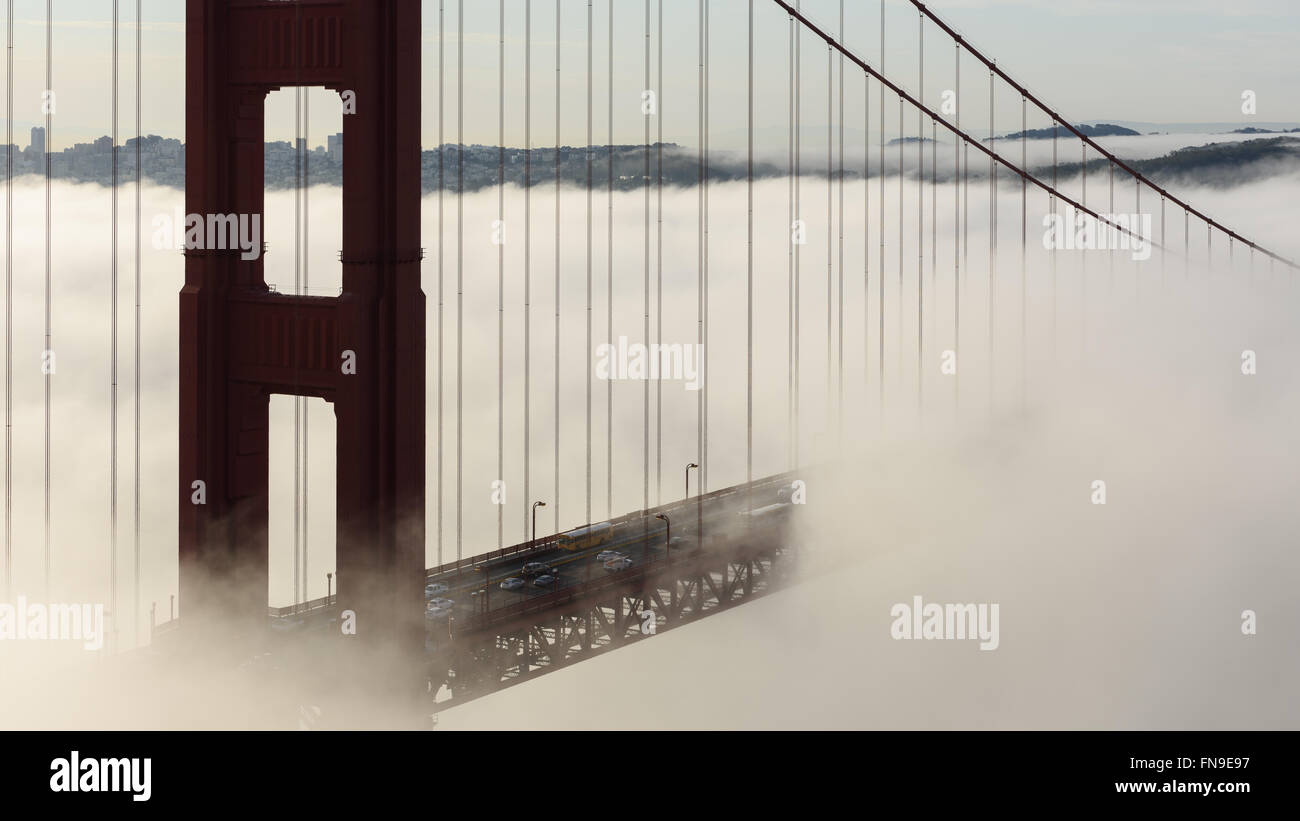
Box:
0 168 1300 729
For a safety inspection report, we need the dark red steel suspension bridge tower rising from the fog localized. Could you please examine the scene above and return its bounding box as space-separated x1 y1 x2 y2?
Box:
178 0 425 652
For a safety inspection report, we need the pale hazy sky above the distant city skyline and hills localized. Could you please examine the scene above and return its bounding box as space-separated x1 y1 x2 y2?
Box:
13 0 1300 149
